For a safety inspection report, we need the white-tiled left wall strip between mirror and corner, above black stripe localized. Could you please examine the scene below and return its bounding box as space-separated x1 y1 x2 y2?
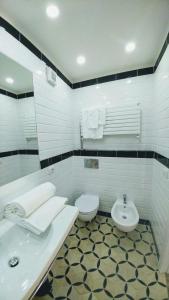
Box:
34 74 74 160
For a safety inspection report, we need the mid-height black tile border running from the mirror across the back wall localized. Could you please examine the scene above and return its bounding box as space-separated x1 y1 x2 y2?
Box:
40 150 169 169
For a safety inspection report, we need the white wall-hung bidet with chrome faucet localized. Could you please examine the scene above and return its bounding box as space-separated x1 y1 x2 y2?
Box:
111 199 139 232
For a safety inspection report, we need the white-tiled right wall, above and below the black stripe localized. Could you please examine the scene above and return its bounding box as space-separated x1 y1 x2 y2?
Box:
150 47 169 264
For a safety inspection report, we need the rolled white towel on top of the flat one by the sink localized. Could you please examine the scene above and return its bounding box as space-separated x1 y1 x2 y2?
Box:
4 182 56 218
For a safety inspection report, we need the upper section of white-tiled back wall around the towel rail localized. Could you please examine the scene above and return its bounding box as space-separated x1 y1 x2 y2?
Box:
73 75 153 150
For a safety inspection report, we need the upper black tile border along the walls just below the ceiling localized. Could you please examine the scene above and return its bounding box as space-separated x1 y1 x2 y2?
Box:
0 17 169 89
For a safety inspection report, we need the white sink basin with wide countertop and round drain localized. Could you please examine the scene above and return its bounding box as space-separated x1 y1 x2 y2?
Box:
0 206 78 300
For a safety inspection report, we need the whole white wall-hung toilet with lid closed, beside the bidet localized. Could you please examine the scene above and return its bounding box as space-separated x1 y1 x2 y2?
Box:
75 194 99 222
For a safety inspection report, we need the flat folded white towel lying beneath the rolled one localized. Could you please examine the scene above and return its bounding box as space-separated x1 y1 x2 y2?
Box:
7 197 68 235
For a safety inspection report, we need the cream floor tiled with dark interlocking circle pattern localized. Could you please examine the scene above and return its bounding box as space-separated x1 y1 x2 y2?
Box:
34 216 168 300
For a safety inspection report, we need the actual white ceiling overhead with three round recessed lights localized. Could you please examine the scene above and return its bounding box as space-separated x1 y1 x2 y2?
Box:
0 0 169 82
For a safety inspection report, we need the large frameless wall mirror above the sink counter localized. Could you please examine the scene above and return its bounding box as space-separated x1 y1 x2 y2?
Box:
0 53 40 185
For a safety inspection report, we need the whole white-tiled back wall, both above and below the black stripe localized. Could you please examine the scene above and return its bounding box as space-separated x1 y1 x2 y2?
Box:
73 75 153 219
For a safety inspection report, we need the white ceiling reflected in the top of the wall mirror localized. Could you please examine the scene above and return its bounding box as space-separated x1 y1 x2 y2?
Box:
0 53 33 94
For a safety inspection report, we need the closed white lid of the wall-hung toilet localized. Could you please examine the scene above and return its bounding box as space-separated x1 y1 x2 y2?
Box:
75 194 99 213
